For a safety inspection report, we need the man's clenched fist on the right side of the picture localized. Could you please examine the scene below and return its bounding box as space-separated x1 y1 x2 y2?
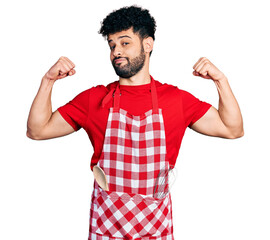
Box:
193 57 225 81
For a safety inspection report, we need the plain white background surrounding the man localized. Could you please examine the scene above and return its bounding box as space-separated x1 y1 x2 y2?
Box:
0 0 270 240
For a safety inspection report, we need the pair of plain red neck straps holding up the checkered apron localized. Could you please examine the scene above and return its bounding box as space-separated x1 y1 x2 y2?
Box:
113 75 158 114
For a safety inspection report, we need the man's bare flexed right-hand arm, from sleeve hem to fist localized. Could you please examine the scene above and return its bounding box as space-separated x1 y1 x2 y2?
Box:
191 58 244 139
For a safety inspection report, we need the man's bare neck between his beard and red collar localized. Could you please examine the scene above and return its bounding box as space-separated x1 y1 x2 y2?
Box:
119 61 151 86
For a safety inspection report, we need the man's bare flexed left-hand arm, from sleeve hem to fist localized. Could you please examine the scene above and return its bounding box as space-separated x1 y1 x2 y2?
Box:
26 57 75 140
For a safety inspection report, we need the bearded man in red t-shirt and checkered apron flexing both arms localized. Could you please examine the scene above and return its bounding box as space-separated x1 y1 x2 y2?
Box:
27 6 244 239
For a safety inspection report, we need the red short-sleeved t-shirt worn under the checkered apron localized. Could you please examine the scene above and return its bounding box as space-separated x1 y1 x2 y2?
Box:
58 76 211 169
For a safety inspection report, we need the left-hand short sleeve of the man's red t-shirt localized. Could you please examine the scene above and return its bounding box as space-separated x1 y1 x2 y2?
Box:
57 90 89 131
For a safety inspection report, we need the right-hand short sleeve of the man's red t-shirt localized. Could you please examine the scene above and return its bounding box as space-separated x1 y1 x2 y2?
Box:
182 91 212 127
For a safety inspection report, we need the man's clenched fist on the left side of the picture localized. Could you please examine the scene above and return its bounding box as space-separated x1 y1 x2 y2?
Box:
45 57 76 81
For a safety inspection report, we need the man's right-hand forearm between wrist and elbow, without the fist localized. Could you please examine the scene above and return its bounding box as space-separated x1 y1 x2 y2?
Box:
214 76 244 137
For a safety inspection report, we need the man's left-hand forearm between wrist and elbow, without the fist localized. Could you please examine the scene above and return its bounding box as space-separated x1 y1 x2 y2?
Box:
27 76 54 138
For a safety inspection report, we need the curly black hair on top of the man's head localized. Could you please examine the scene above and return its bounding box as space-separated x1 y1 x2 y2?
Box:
98 5 156 40
